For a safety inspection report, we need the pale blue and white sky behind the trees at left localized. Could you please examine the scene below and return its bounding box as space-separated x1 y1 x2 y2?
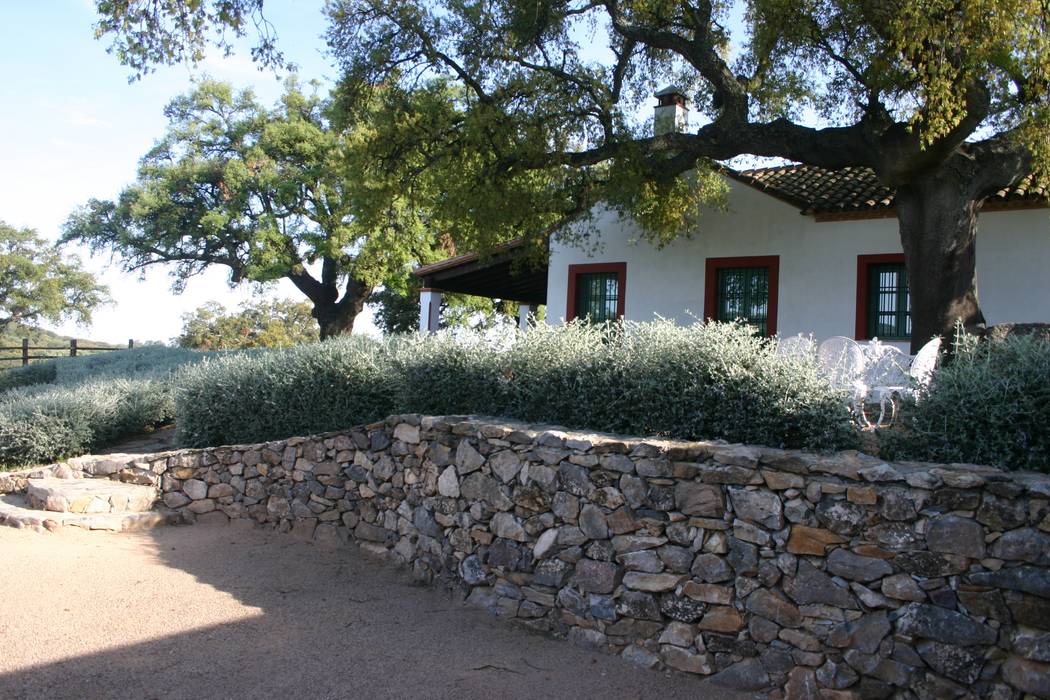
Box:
0 0 377 343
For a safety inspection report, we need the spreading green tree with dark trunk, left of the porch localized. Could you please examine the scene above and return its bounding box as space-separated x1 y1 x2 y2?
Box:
63 80 432 338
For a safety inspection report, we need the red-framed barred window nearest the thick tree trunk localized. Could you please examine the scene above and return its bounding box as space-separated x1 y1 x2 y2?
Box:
857 253 911 340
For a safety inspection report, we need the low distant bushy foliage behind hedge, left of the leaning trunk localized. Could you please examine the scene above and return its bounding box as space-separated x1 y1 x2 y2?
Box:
174 299 318 349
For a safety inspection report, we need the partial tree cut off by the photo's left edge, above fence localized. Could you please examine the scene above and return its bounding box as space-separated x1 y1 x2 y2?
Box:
0 221 109 332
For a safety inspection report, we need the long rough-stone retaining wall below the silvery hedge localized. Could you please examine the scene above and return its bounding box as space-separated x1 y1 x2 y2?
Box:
8 416 1050 700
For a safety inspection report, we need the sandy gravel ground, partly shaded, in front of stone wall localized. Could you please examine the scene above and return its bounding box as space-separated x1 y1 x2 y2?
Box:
0 523 760 700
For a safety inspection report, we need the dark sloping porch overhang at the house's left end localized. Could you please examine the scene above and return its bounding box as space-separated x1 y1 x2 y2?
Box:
413 240 547 306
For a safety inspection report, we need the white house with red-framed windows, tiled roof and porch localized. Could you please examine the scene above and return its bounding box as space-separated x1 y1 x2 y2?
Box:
416 92 1050 348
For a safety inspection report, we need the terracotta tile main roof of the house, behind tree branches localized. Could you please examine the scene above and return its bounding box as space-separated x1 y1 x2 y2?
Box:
729 164 1050 214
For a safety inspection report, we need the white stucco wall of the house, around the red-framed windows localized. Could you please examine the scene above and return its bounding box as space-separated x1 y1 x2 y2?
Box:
547 182 1050 340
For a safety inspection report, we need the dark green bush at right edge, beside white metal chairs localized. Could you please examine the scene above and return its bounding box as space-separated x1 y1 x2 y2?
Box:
893 336 1050 471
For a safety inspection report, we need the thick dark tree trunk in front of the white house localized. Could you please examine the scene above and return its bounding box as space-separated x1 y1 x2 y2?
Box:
897 168 985 353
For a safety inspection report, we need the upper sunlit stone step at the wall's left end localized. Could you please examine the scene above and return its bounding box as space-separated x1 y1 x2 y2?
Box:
26 479 158 514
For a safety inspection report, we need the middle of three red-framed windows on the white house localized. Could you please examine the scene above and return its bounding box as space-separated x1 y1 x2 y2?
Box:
704 255 780 336
